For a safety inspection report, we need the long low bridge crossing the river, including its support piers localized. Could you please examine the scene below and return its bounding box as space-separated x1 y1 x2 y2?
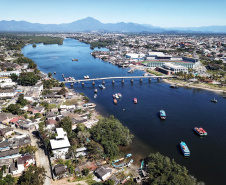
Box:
62 75 176 84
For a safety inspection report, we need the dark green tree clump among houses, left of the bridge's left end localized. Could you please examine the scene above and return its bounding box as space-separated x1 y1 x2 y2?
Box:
17 72 40 86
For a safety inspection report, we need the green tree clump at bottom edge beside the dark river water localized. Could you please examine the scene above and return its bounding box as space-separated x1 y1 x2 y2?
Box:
147 153 201 185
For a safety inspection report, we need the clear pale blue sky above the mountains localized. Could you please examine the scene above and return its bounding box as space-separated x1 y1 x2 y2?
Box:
0 0 226 28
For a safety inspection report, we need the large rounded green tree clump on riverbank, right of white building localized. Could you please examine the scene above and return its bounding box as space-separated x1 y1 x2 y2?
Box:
90 116 133 159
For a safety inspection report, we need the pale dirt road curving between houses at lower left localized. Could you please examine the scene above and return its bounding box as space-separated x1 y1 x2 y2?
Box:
14 129 51 185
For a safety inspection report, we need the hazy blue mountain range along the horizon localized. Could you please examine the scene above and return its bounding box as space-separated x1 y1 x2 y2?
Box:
0 17 226 33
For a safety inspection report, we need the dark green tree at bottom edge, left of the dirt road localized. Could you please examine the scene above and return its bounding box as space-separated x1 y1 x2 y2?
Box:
18 166 46 185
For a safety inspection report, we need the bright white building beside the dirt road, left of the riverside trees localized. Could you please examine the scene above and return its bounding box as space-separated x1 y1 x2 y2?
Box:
50 128 71 159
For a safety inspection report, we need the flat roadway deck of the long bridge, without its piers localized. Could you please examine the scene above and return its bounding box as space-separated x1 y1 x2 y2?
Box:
61 76 175 83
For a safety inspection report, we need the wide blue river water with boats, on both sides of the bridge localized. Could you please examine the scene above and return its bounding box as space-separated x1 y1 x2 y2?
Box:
22 39 226 185
